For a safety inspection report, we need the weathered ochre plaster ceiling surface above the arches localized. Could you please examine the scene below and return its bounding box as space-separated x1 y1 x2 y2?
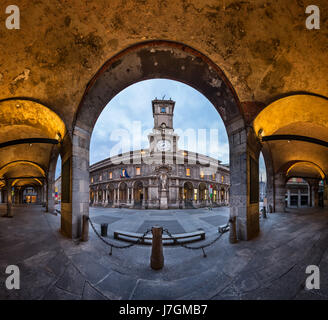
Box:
0 0 328 128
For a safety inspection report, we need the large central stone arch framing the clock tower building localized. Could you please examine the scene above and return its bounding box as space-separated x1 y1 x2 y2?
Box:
72 40 259 240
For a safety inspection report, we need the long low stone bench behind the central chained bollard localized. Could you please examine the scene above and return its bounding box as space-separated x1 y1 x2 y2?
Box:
114 230 205 246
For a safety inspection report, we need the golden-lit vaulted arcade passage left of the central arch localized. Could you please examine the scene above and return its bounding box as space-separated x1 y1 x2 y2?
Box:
0 98 71 225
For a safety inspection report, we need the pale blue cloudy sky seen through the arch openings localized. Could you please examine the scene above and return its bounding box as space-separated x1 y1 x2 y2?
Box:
56 79 265 180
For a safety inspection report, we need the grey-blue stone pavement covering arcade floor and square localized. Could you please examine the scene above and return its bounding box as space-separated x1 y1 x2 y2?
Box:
0 206 328 300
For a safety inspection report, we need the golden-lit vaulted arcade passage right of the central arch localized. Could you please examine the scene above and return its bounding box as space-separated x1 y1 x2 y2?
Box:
253 92 328 212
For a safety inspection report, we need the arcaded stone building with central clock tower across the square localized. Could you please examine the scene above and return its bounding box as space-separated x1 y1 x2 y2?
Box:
90 99 230 209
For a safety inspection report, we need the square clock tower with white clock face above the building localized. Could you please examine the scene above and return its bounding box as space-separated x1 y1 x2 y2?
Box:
148 99 179 153
